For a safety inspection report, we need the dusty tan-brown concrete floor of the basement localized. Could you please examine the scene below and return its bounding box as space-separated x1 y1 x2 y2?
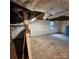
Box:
10 34 69 59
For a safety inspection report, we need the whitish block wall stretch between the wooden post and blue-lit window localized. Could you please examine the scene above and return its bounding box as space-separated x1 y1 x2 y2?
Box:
29 20 56 36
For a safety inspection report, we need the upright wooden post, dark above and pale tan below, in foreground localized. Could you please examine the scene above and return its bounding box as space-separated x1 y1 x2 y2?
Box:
23 12 32 59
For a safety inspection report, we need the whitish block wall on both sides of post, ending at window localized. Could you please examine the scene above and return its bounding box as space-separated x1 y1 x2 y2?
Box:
12 20 56 39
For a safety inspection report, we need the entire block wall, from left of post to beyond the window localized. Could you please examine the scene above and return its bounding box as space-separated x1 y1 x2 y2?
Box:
12 20 68 39
